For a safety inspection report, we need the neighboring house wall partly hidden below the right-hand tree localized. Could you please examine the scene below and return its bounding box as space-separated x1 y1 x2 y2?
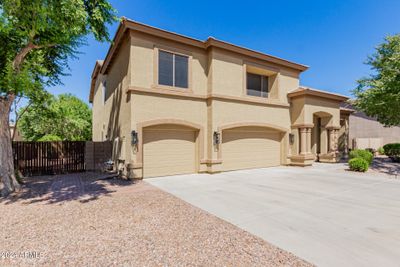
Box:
341 103 400 152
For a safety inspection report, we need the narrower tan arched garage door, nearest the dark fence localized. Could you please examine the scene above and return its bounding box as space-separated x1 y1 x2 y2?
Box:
143 126 196 178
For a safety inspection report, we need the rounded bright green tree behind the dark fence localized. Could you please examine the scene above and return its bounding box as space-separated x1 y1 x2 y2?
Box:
18 94 92 141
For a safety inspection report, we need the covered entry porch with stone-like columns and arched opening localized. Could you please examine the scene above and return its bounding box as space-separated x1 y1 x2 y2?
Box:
288 87 348 166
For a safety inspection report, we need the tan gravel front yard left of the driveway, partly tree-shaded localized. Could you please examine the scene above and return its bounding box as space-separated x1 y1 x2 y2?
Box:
0 173 311 266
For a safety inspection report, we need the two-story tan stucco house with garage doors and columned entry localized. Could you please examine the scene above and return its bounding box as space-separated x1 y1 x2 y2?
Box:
89 19 347 178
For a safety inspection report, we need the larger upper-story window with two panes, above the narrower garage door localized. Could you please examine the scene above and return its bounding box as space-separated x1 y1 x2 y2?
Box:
158 50 189 88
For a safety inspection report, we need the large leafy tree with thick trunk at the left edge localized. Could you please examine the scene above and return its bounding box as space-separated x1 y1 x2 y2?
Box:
0 0 116 196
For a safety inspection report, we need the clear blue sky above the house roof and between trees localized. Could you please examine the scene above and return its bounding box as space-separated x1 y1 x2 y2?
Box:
50 0 400 101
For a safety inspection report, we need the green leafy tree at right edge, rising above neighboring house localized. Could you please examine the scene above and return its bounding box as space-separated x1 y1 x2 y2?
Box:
354 35 400 126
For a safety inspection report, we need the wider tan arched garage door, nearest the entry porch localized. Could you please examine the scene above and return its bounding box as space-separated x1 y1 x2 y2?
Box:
222 127 282 171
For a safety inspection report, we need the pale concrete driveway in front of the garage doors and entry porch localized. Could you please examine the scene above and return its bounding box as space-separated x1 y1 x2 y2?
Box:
146 164 400 267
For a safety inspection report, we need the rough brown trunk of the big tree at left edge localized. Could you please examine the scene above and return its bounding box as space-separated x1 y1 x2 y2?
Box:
0 94 20 196
